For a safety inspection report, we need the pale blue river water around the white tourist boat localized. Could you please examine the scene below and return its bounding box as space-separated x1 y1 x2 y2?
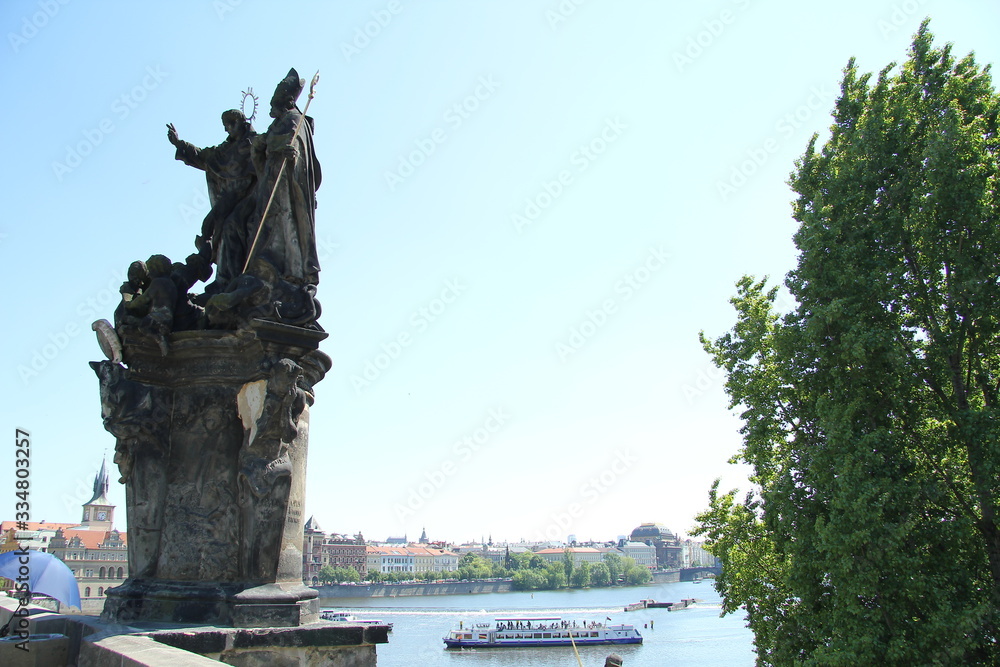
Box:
320 581 754 667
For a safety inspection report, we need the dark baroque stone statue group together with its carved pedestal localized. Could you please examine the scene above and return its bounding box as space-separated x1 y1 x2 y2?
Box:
91 69 331 627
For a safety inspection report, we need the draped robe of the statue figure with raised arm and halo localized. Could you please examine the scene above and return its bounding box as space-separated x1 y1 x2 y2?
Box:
174 124 257 291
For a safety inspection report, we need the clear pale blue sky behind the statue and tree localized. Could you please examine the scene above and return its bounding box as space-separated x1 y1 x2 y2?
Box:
0 0 1000 541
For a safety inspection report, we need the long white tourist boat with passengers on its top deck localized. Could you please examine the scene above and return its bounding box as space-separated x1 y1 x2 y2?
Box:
443 616 642 648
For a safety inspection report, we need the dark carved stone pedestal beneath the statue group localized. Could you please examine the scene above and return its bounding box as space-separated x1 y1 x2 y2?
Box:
93 321 331 627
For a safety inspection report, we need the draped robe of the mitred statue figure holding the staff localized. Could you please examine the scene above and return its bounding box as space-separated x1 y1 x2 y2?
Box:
254 107 322 285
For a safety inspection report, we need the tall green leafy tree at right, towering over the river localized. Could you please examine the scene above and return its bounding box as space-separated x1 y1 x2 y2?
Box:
697 22 1000 665
